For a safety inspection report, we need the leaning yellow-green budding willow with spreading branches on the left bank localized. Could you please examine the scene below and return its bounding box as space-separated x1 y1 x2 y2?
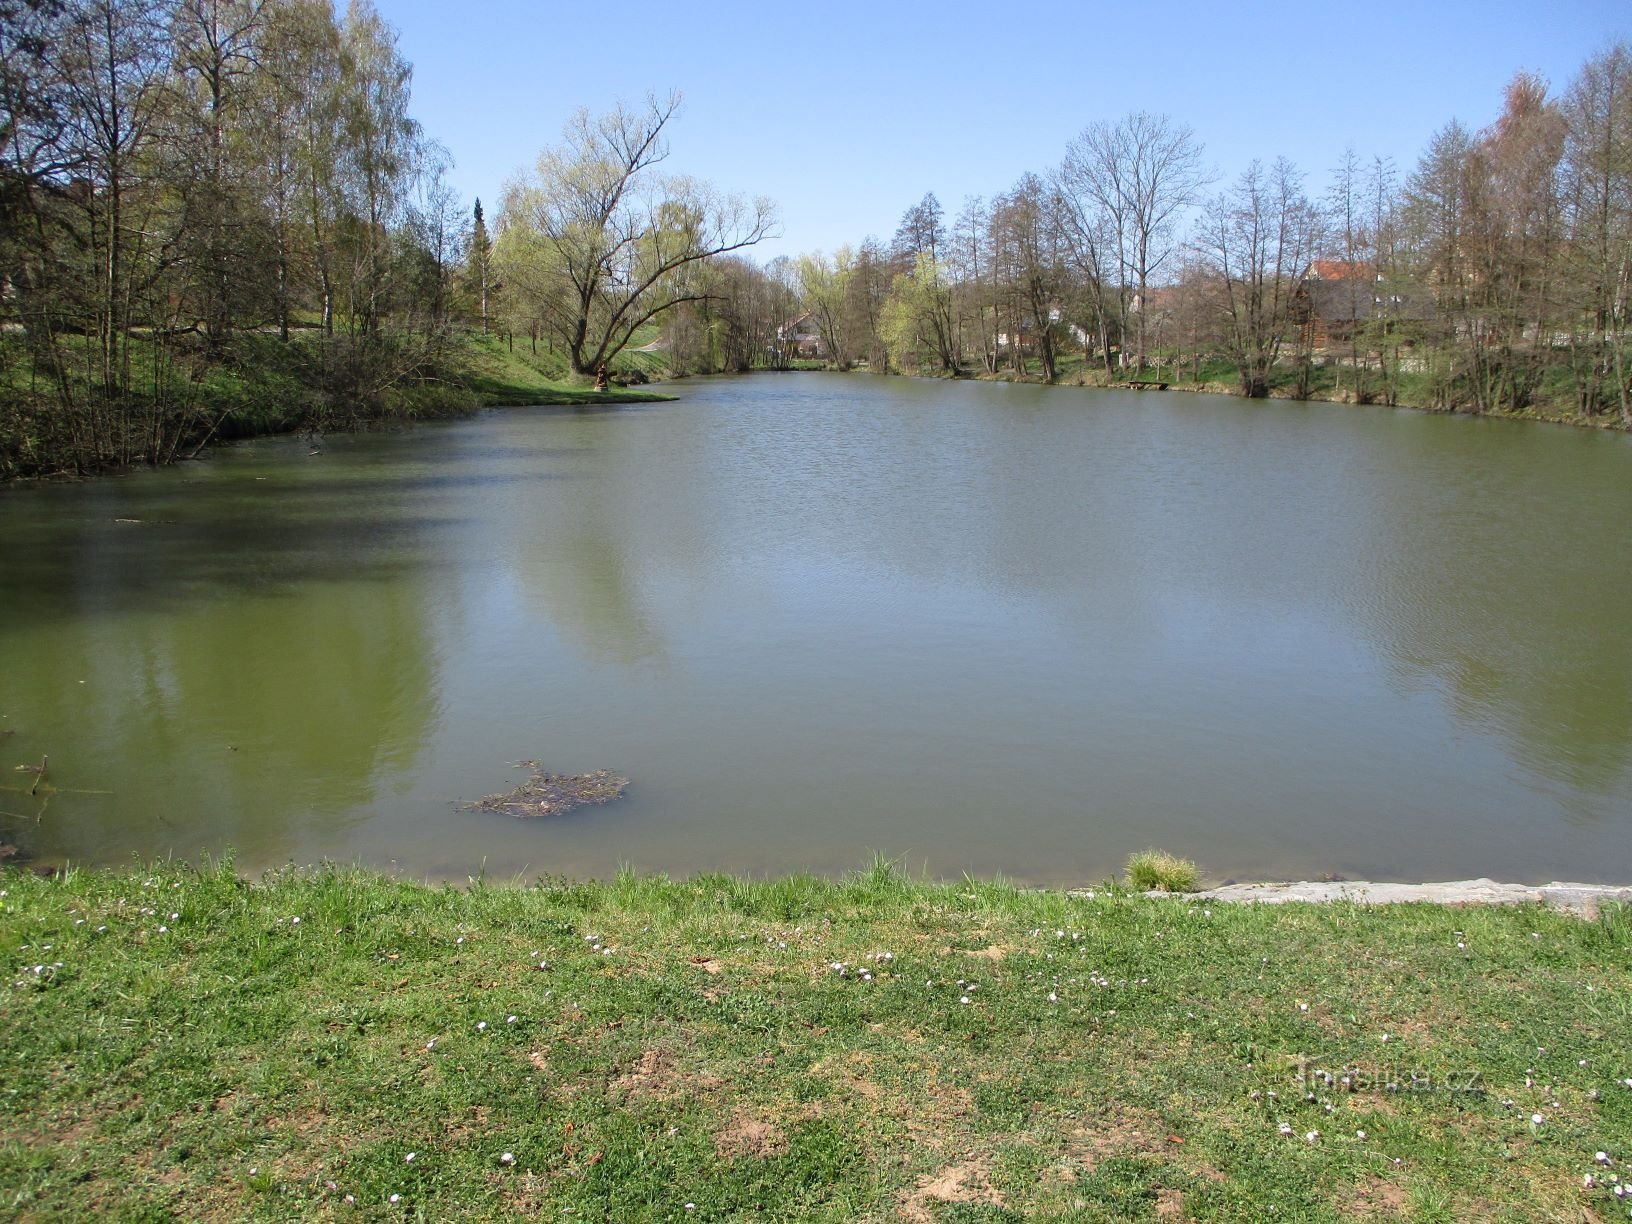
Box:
494 95 775 374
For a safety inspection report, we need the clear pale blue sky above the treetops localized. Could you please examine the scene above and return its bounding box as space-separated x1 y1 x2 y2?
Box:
388 0 1632 258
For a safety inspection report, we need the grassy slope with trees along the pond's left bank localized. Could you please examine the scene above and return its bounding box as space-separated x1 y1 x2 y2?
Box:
0 0 772 478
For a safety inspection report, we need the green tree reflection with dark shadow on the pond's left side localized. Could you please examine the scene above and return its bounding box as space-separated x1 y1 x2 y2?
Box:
0 440 447 863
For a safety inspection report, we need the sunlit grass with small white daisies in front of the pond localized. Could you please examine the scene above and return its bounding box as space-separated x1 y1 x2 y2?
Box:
0 865 1632 1224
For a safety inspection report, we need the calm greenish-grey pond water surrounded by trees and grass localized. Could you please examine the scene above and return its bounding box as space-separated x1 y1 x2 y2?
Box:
0 374 1632 885
